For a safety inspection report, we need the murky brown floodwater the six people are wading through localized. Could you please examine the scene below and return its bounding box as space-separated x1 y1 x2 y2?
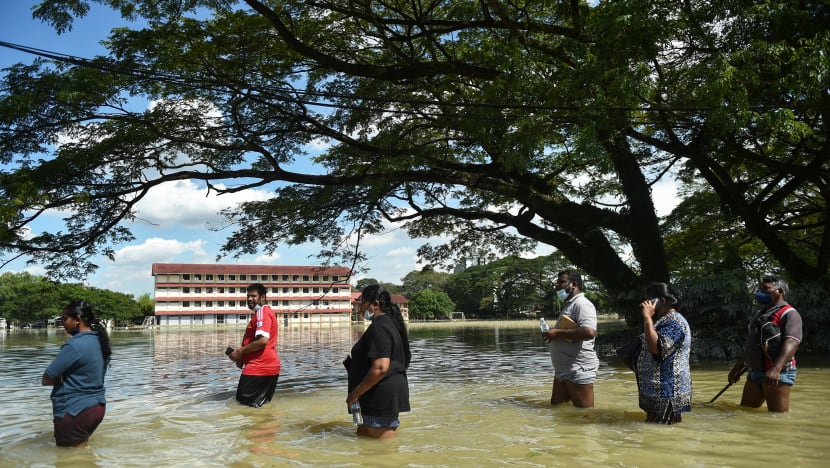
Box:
0 322 830 467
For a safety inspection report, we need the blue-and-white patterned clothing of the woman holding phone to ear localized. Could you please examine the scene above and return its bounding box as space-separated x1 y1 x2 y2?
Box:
634 310 692 423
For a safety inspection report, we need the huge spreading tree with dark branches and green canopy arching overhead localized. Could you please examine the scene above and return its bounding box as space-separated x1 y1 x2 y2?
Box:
0 0 830 314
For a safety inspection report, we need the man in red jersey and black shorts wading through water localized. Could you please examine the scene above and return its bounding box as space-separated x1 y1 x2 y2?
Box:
230 283 280 408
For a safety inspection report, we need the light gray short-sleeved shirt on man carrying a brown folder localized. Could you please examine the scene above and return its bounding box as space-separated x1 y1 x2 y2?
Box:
549 293 599 372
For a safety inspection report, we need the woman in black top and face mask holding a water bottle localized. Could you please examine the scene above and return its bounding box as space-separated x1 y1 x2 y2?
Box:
346 284 412 438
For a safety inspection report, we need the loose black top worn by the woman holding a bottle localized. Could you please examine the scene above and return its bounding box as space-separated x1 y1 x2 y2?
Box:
348 314 410 416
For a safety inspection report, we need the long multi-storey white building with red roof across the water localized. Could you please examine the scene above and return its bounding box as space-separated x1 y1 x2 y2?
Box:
153 263 352 326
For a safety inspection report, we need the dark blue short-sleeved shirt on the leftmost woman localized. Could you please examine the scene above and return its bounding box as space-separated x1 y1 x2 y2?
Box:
46 331 107 418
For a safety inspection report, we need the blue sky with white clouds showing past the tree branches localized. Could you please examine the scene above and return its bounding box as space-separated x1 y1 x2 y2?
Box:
0 0 674 296
